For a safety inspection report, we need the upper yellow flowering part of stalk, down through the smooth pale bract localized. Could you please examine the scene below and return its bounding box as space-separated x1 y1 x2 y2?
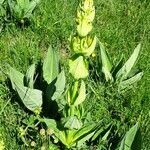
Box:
69 0 96 80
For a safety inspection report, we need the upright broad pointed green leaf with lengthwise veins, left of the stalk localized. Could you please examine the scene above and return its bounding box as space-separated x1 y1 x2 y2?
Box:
43 46 59 84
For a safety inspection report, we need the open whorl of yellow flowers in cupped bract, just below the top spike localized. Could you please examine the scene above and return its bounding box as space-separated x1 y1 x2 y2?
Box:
71 36 97 56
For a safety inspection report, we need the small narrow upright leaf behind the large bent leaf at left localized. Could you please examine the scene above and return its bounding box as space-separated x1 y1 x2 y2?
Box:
25 64 35 89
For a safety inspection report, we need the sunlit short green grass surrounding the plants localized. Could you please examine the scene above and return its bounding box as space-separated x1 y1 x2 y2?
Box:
0 0 150 150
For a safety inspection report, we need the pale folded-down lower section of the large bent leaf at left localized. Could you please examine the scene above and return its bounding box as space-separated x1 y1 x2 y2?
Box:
15 84 42 112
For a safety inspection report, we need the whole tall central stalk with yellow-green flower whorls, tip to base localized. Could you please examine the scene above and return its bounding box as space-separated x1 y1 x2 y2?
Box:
62 0 96 148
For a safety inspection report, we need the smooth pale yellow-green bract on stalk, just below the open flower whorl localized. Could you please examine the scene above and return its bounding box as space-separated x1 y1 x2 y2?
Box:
69 56 88 80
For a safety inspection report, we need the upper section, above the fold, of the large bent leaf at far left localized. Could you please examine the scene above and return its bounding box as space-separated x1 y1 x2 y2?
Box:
8 67 24 90
